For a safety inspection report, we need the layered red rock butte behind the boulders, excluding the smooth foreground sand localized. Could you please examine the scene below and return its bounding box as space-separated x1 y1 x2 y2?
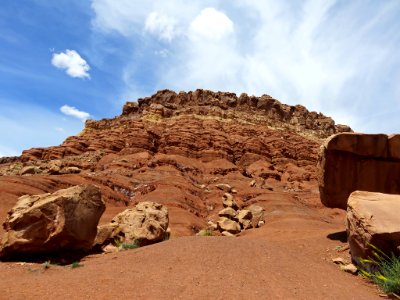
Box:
0 90 350 236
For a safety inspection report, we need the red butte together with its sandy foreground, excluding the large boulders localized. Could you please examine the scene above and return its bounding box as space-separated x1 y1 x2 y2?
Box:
0 90 380 299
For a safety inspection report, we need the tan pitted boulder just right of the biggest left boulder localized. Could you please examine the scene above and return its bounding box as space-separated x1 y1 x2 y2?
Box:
95 201 169 246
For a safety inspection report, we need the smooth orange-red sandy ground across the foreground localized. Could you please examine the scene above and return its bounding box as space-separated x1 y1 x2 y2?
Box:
0 209 381 299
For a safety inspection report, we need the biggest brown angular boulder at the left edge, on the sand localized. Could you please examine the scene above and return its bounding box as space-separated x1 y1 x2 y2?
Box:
0 185 105 258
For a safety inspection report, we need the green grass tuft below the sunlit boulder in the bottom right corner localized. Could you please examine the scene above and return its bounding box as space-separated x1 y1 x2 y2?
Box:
360 245 400 296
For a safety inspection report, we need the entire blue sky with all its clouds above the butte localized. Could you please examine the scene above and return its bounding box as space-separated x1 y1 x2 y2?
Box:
0 0 400 156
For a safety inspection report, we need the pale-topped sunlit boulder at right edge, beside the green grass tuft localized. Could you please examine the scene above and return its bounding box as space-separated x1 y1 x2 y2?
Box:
347 191 400 262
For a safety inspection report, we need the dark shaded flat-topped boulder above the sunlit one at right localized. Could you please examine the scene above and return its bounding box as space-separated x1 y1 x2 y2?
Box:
318 133 400 209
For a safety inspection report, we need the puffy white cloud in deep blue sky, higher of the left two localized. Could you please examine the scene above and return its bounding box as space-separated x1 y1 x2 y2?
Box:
51 49 90 78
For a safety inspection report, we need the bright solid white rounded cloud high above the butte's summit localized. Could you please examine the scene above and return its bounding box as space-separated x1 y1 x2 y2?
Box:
189 7 234 40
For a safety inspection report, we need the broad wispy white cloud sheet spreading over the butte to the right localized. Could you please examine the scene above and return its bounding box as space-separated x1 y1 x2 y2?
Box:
92 0 400 131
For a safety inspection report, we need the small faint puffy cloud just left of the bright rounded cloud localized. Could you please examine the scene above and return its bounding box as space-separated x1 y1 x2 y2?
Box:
144 12 177 42
